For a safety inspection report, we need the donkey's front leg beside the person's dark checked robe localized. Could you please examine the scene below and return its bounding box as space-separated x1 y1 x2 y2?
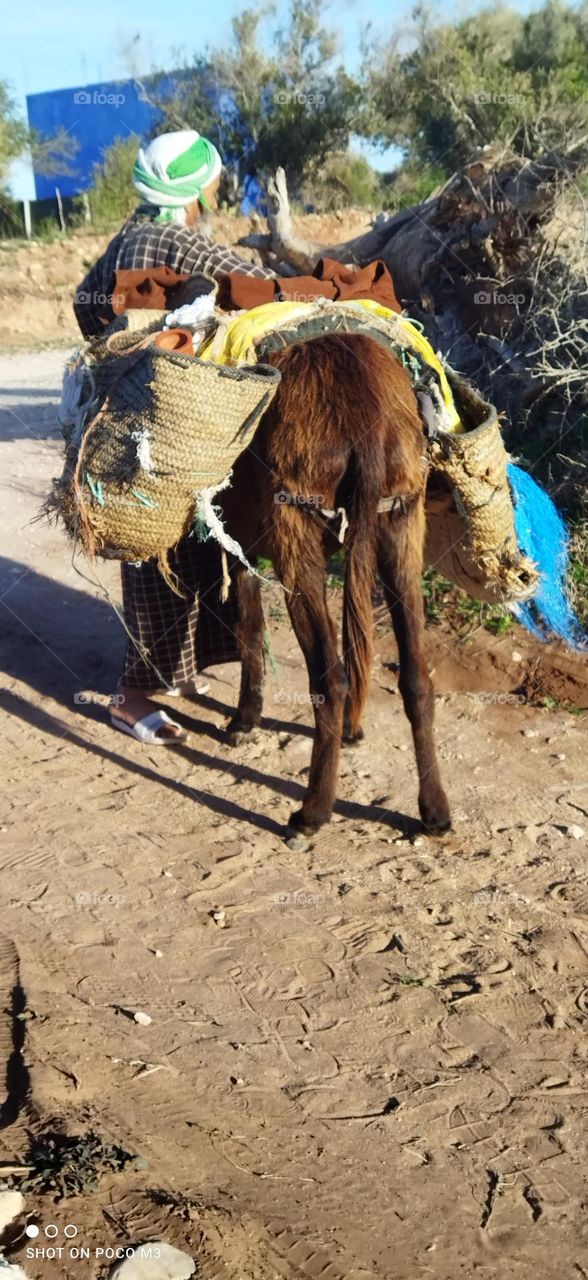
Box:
227 564 265 746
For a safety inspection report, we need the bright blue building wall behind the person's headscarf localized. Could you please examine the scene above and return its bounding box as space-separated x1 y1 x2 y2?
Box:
27 81 162 200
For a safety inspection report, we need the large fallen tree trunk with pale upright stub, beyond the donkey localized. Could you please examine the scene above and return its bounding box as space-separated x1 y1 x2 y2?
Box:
241 147 584 435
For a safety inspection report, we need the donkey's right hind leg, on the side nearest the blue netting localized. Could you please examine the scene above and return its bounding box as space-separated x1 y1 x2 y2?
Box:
378 498 451 835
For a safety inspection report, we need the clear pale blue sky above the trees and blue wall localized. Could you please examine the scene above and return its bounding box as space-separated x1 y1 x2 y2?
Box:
0 0 541 198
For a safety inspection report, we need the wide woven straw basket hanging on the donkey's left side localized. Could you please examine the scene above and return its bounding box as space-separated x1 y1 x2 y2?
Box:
53 330 281 564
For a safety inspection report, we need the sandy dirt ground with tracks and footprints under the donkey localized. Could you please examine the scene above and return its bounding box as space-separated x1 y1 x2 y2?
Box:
0 351 588 1280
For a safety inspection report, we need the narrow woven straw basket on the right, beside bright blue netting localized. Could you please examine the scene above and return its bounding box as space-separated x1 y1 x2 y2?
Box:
425 369 538 603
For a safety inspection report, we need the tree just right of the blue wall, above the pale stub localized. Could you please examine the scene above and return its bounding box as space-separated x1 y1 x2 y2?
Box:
154 0 360 195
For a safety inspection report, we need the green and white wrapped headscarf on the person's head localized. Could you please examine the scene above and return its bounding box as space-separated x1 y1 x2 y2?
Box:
133 129 223 223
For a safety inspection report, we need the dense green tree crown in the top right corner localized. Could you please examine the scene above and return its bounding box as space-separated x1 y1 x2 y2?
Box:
363 0 588 174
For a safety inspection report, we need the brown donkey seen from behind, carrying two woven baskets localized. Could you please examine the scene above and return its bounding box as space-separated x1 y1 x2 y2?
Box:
216 334 451 838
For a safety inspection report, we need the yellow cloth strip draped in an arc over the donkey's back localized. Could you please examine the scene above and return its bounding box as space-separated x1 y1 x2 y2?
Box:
197 298 461 431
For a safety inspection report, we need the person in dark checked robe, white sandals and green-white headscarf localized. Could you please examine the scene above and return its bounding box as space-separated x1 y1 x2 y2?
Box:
74 129 269 744
